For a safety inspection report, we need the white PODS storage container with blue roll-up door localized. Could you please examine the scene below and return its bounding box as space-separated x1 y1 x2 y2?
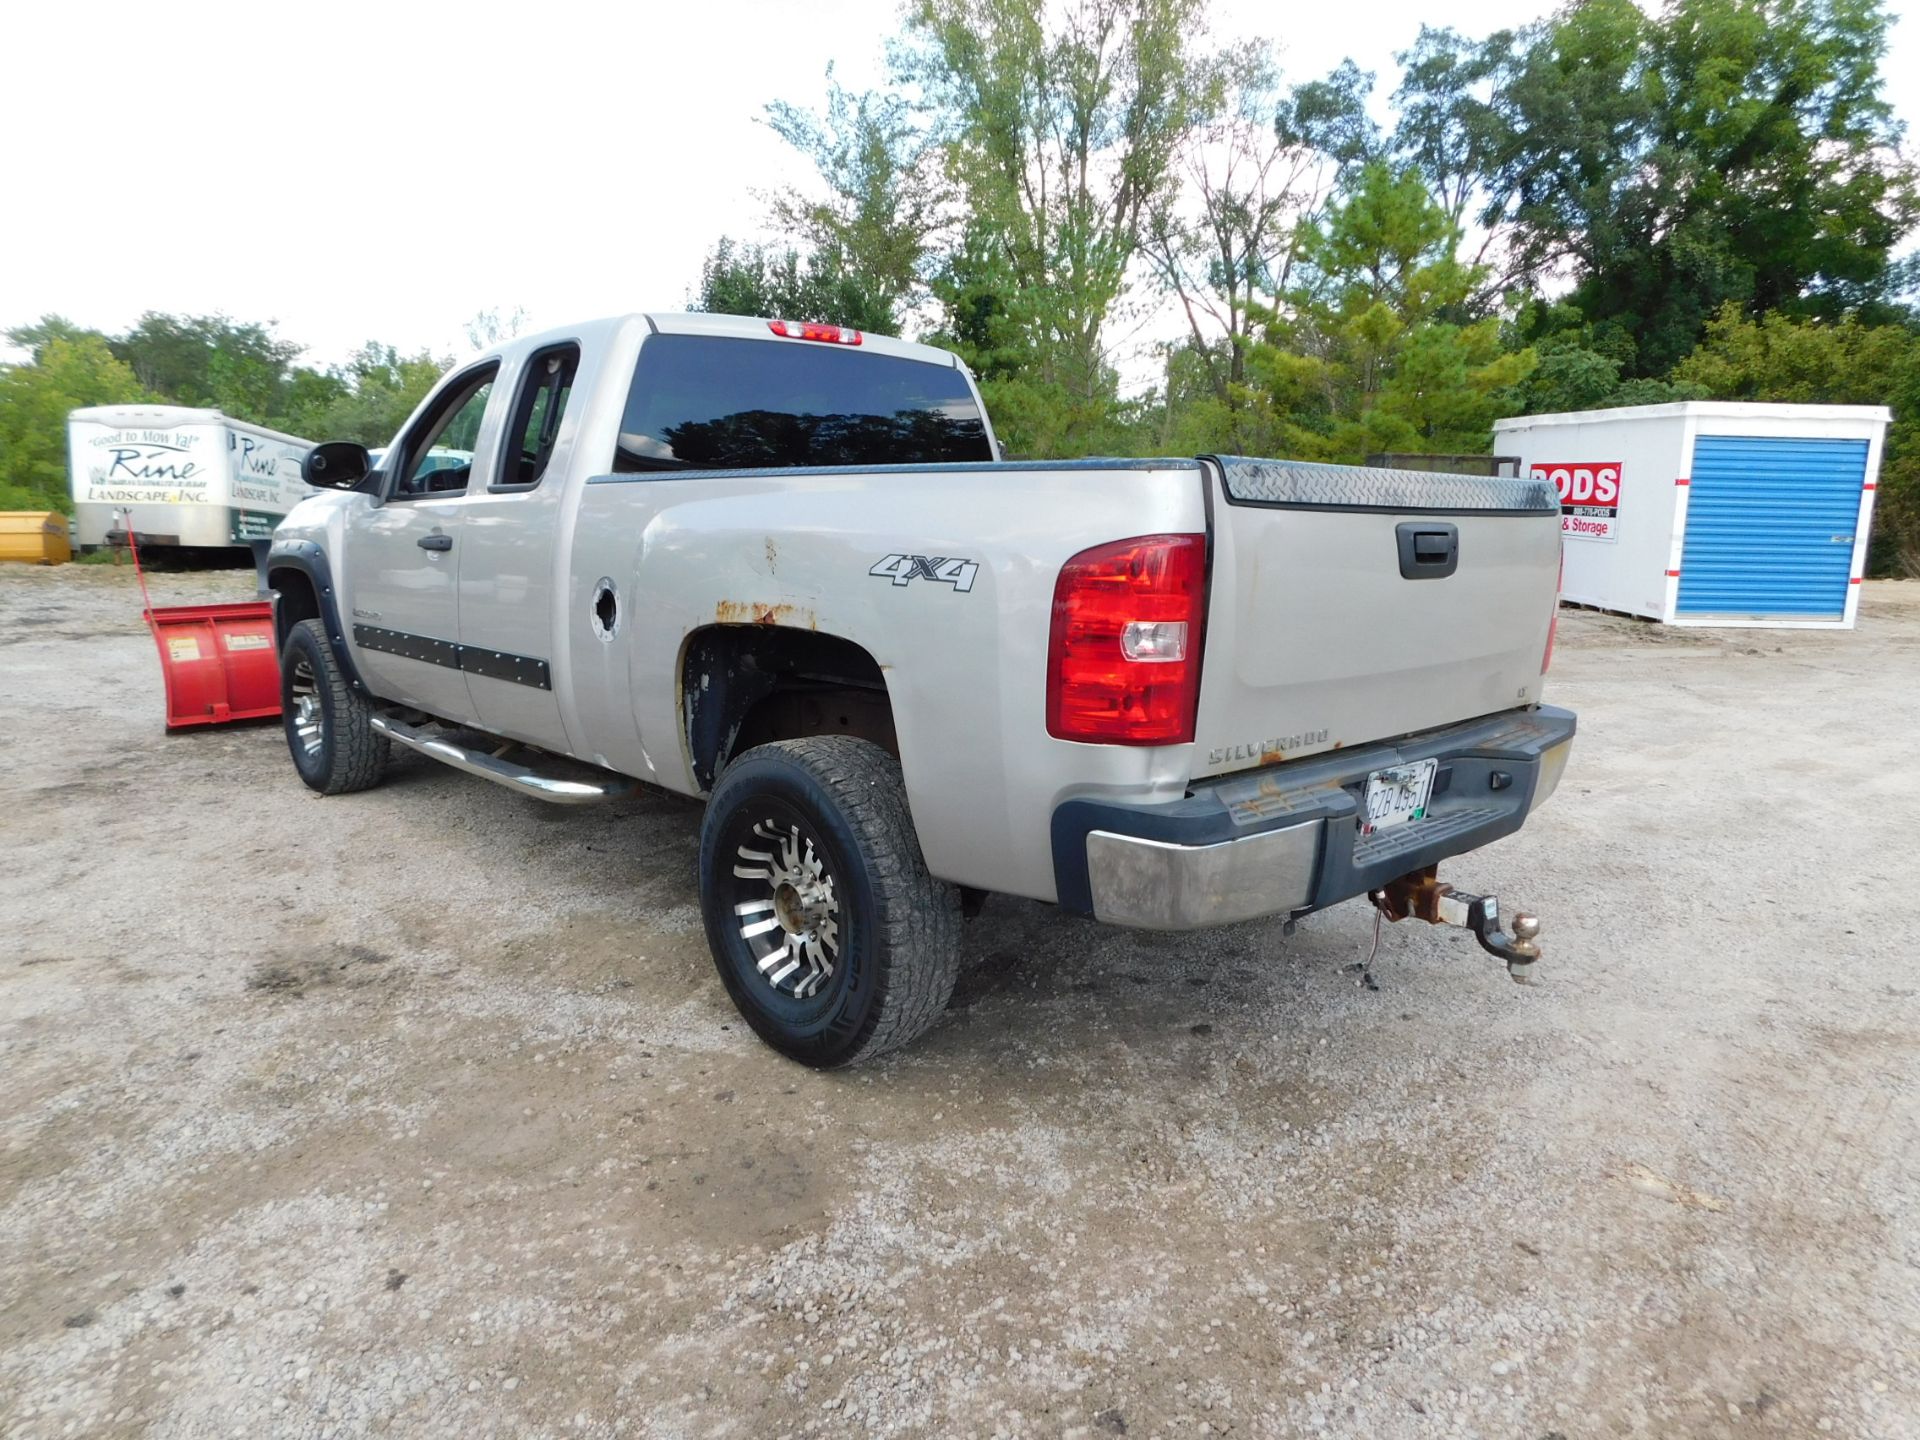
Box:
1494 401 1893 628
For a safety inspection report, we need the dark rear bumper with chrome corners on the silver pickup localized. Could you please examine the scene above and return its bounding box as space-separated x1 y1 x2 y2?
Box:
1052 705 1574 929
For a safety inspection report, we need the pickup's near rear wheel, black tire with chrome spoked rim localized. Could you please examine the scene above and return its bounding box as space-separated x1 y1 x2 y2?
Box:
701 735 960 1069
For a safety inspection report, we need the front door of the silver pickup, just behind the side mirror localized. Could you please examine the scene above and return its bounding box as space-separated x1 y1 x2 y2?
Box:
346 361 499 720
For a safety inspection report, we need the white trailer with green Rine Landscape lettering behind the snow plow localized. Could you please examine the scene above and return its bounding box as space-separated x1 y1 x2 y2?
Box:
67 405 313 547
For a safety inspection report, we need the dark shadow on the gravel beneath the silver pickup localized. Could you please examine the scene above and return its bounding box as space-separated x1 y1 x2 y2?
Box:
232 721 1354 1079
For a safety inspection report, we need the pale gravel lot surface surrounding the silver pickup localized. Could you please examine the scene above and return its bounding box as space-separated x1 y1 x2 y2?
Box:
0 566 1920 1440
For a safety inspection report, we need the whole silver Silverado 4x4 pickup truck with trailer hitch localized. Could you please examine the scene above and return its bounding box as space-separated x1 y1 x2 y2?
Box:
269 315 1574 1066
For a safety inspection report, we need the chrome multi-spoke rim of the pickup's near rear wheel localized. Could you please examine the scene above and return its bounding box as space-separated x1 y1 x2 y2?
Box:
733 820 839 1000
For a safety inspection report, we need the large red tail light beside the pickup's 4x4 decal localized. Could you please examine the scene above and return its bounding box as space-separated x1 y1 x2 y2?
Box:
1046 536 1206 745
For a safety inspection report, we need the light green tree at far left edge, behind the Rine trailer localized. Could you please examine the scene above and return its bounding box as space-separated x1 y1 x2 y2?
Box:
0 336 152 513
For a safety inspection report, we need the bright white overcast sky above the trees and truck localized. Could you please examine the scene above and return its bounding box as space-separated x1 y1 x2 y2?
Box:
11 0 1920 378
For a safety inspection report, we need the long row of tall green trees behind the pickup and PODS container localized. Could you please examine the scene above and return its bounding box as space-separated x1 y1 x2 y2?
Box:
695 0 1920 572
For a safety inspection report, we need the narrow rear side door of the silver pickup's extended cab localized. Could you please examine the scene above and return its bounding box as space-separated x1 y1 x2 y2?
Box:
461 342 580 751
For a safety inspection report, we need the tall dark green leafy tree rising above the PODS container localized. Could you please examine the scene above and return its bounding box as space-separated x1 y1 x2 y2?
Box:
1461 0 1920 376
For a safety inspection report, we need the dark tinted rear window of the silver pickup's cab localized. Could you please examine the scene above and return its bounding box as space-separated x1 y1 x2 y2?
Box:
612 334 993 472
